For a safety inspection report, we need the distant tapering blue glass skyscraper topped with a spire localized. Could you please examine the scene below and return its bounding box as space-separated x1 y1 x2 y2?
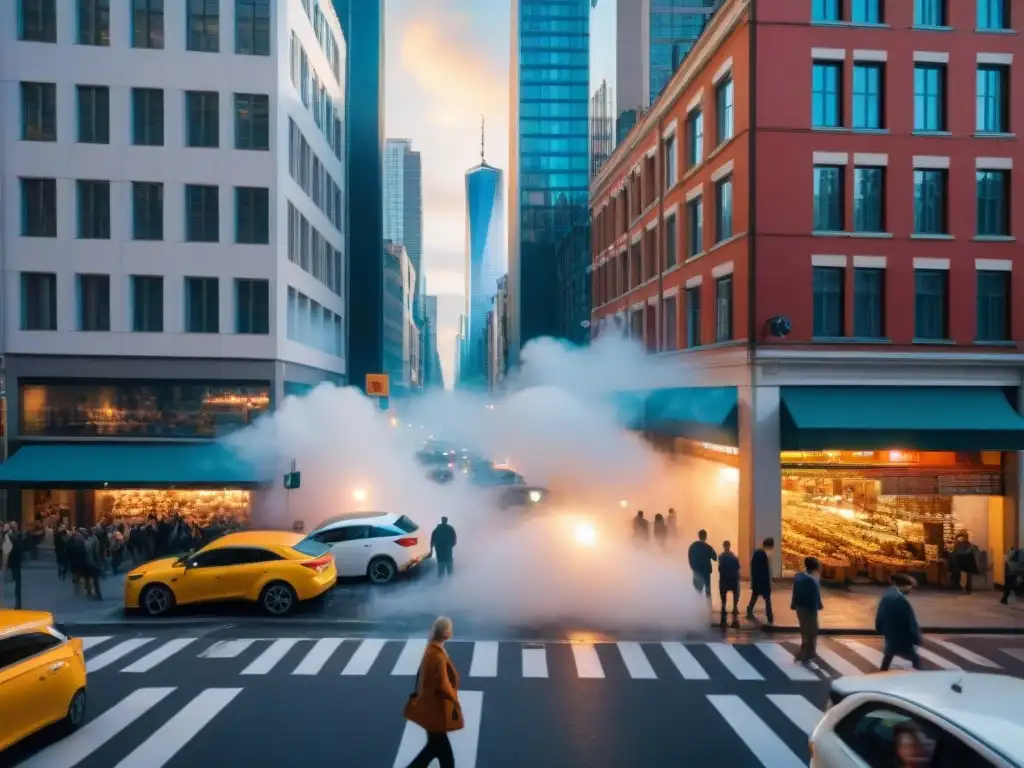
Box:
458 124 505 387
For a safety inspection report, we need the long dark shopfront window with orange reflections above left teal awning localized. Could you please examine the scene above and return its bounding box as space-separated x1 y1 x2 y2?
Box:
19 381 270 438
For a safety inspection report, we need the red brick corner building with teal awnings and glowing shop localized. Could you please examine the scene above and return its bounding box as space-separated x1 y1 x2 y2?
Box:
591 0 1024 583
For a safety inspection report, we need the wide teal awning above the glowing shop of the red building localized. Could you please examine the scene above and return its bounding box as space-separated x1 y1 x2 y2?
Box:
781 386 1024 451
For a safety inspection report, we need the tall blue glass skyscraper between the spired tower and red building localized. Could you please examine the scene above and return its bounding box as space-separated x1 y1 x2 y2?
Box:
508 0 591 366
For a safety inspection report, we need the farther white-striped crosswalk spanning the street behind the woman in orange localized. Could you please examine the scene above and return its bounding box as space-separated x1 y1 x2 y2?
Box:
75 636 1024 682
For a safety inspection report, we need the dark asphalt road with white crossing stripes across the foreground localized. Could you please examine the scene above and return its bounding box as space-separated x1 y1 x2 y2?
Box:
8 626 1024 768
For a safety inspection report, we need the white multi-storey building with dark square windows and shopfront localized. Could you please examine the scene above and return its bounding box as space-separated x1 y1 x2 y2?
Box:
0 0 348 521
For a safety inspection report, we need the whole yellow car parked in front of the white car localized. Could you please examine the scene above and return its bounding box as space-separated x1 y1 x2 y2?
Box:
125 530 338 616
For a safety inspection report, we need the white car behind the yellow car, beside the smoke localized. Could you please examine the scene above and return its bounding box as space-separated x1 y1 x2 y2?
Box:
308 512 430 584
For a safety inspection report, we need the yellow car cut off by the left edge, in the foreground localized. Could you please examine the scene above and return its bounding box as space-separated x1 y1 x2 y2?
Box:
0 610 85 752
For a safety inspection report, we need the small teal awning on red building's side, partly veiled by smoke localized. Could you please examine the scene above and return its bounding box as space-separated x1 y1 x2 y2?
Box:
644 387 739 446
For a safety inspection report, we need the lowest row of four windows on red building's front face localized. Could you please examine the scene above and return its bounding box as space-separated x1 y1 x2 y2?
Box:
812 266 1012 343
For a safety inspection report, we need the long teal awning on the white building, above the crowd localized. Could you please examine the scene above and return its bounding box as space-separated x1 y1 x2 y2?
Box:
0 442 267 487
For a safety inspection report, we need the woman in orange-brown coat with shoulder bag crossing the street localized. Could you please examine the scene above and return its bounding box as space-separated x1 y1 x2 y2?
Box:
402 616 463 768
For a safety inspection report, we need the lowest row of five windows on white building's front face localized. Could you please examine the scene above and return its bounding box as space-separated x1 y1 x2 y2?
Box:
20 272 270 335
